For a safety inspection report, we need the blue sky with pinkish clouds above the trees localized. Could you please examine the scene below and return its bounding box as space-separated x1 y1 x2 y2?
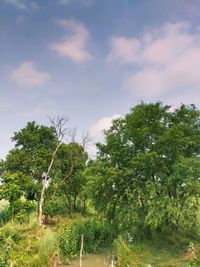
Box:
0 0 200 159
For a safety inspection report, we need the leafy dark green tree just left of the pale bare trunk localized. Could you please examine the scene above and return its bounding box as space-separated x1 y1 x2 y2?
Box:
4 122 56 200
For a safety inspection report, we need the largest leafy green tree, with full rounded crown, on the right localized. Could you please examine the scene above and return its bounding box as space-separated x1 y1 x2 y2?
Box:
90 102 200 236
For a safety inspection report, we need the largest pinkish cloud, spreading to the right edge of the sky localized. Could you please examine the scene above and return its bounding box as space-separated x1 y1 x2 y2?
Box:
108 22 200 100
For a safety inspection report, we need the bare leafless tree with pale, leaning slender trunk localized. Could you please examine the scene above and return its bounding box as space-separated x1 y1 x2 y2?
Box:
38 116 68 226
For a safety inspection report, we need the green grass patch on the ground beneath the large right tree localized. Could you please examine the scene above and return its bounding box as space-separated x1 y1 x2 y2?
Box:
115 235 200 267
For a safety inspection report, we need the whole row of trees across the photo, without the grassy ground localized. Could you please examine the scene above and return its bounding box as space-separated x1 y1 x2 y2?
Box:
0 102 200 239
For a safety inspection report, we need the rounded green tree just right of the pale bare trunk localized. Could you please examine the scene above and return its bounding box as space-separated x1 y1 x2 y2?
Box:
46 142 88 215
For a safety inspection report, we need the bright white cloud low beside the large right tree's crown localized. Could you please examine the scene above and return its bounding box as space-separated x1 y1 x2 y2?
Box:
88 114 121 158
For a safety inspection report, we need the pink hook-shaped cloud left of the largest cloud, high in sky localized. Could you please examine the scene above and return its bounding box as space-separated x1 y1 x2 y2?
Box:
50 20 92 63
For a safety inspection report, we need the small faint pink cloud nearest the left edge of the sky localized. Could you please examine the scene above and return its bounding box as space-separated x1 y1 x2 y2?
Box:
10 61 50 87
